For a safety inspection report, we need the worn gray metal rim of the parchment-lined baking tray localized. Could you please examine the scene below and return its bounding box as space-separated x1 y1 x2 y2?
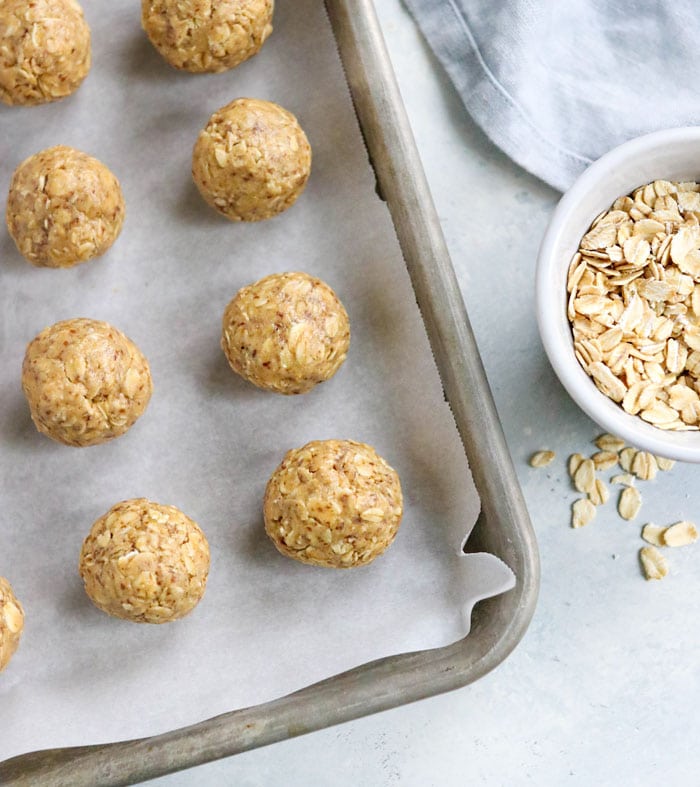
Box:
0 0 539 787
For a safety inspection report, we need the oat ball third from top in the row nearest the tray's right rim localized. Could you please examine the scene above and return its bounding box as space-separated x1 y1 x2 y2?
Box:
221 273 350 394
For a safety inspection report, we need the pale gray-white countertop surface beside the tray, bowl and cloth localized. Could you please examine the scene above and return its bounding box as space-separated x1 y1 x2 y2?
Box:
152 0 700 787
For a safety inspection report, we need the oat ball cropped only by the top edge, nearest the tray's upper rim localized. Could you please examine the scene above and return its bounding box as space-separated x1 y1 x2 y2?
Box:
141 0 274 73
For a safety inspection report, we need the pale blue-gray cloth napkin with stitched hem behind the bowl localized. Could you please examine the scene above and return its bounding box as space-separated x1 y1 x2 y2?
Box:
404 0 700 190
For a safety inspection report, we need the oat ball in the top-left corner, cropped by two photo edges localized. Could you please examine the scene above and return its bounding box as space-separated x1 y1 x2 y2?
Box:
0 0 90 105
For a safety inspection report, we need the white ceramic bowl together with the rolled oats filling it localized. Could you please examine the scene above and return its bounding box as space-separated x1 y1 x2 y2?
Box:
537 127 700 462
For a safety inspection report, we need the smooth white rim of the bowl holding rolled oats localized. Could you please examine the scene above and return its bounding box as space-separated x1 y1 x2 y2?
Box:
535 126 700 463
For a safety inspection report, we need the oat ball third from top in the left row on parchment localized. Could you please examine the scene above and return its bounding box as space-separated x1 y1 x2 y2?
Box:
22 319 153 447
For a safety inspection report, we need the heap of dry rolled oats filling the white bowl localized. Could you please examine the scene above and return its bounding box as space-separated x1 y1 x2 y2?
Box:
567 180 700 430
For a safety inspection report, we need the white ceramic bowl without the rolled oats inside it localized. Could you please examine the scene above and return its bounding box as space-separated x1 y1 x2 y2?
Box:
536 127 700 462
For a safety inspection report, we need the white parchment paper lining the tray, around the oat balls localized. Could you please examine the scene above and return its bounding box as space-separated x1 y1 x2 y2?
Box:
0 0 513 759
